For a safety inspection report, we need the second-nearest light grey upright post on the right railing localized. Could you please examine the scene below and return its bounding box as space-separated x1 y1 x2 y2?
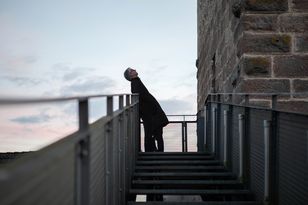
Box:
238 114 245 182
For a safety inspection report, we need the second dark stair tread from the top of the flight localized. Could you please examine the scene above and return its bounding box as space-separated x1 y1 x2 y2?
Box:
136 160 221 166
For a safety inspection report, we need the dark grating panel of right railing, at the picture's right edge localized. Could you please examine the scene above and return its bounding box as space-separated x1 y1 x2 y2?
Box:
278 113 308 205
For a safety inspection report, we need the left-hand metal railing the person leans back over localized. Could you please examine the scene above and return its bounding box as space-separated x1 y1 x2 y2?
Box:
0 94 140 205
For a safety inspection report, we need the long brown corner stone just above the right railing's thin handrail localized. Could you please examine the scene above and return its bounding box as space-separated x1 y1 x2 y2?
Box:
239 79 290 93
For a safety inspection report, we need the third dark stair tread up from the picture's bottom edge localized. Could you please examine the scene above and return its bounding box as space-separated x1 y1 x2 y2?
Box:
133 180 241 185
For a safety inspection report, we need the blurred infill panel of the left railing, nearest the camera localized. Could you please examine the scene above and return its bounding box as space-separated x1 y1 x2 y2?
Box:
0 136 75 205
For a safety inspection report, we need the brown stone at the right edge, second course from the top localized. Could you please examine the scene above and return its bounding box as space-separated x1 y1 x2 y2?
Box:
279 13 308 33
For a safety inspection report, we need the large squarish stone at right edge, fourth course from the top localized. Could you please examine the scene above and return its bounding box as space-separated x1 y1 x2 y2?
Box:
273 55 308 78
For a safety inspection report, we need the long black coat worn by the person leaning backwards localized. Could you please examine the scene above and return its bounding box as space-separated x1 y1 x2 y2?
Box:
131 78 169 129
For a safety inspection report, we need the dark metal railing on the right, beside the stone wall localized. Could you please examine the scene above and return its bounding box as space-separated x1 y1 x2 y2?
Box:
198 93 308 205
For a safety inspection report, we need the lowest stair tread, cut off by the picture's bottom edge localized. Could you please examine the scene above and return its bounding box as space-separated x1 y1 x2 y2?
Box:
127 201 263 205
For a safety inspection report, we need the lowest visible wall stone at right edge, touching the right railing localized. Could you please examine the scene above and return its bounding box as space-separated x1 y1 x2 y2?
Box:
277 101 308 114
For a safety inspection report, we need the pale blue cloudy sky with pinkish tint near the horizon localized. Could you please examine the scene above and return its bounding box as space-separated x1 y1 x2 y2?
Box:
0 0 197 152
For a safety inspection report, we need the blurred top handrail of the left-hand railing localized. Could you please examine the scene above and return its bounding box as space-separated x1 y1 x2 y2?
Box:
0 93 138 105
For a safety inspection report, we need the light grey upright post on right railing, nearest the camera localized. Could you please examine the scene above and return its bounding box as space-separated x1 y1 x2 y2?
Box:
263 120 271 202
